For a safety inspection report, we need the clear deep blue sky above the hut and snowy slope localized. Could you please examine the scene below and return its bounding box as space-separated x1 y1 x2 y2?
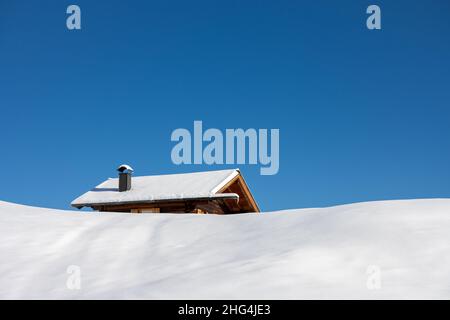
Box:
0 0 450 210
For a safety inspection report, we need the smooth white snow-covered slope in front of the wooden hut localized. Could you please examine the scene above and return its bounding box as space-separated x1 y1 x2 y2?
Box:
0 199 450 299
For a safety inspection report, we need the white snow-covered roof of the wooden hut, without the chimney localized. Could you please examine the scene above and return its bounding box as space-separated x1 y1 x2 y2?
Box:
72 169 240 207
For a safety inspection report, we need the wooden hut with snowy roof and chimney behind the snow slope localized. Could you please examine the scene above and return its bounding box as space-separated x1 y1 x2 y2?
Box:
71 165 260 214
